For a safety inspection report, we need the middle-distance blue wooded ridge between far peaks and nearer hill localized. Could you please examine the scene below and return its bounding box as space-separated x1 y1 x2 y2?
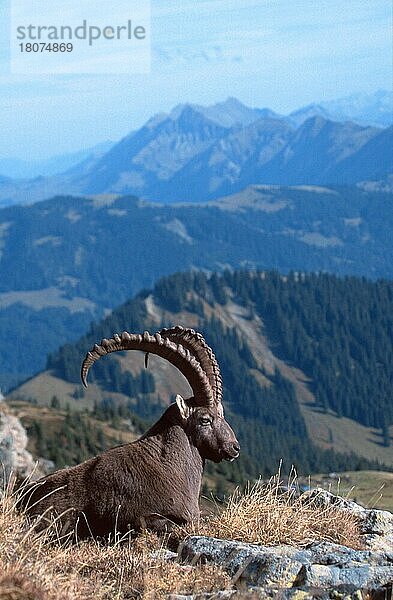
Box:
0 185 393 388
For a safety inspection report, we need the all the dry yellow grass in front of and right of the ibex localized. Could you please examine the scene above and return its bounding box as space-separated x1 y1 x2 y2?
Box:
0 476 360 600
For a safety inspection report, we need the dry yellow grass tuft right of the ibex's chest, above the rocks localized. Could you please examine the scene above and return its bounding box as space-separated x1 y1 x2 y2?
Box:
182 473 362 548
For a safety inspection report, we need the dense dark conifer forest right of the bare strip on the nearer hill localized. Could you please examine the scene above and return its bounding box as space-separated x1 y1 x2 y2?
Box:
251 274 393 429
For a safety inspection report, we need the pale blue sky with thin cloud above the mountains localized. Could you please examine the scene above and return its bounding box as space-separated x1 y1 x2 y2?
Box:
0 0 392 159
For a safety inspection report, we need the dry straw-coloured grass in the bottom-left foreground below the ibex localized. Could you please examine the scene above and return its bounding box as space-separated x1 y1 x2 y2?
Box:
0 476 231 600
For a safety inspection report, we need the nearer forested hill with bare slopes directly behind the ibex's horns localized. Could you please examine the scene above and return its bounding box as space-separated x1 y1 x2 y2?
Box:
11 271 393 492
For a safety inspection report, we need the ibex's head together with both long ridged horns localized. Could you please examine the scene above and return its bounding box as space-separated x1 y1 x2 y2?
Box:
81 326 240 462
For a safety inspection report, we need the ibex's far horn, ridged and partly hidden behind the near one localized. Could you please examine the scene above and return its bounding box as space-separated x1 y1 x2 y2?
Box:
159 325 222 404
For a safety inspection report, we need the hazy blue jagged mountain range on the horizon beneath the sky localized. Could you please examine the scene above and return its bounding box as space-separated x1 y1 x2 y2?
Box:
0 91 393 206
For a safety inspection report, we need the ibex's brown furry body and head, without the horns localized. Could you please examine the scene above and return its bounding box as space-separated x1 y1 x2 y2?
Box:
21 397 240 538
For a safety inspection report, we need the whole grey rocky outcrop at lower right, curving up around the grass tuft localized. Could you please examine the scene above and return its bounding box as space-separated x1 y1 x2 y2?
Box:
175 490 393 600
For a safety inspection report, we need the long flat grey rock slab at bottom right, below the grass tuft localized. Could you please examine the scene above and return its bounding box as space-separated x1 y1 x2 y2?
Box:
180 536 393 597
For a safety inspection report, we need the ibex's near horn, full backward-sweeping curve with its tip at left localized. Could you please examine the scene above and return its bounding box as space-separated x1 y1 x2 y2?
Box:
81 331 214 406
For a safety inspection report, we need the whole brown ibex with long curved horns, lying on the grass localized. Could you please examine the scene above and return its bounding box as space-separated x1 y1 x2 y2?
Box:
22 326 240 538
